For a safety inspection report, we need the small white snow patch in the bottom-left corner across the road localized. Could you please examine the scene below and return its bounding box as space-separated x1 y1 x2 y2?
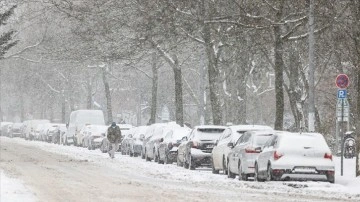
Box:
0 170 36 202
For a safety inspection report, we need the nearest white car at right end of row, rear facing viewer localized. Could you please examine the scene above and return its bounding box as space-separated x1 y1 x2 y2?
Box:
255 132 335 183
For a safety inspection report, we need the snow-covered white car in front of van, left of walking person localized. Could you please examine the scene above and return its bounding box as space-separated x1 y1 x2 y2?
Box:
83 125 108 150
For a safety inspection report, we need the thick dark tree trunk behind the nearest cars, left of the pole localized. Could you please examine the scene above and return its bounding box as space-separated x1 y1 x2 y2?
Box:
274 24 284 130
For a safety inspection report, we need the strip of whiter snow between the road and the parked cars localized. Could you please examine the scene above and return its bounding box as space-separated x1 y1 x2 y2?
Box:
4 138 360 201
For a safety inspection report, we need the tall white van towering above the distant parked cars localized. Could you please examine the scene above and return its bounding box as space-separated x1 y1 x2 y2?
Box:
63 110 105 146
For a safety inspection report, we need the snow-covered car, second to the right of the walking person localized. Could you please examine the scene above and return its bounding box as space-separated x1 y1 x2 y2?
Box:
129 126 148 157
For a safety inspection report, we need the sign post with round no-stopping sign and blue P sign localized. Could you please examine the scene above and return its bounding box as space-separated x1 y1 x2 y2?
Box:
335 74 350 176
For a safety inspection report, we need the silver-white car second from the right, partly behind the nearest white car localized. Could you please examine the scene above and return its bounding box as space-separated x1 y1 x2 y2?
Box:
227 130 275 181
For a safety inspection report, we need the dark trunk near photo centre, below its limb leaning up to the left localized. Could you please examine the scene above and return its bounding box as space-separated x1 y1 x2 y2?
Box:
173 66 184 127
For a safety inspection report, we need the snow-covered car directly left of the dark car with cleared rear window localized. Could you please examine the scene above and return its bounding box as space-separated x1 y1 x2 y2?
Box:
158 127 191 164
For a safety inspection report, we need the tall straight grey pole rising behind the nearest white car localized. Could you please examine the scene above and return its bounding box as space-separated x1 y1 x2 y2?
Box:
308 0 315 132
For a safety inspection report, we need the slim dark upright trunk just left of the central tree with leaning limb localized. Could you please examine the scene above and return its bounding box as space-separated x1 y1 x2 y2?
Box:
148 52 158 125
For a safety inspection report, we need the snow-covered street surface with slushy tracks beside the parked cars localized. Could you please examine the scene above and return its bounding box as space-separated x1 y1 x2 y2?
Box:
0 137 360 202
